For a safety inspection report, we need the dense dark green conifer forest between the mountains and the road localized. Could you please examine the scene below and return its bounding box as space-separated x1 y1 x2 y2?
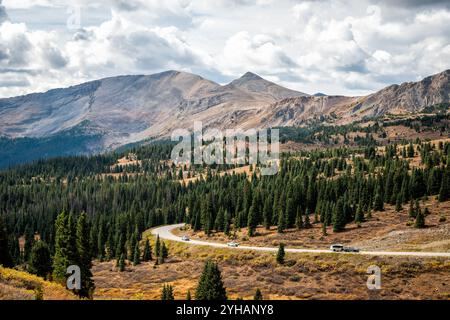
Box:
0 116 450 298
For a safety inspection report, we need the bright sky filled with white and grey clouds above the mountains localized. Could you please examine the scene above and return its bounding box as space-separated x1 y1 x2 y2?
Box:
0 0 450 97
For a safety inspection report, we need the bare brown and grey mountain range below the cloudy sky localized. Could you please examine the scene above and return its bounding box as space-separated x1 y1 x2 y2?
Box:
0 70 450 167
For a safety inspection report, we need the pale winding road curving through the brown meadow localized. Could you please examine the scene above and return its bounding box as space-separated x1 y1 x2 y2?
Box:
152 223 450 258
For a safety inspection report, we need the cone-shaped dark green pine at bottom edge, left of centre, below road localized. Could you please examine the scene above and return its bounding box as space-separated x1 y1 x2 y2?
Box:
195 260 227 301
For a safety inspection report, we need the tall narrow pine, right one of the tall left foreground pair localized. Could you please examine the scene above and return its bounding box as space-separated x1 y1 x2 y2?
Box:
76 212 95 298
